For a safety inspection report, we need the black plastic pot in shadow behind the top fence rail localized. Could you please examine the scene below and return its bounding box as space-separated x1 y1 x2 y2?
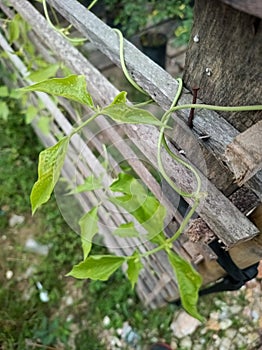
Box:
140 33 167 68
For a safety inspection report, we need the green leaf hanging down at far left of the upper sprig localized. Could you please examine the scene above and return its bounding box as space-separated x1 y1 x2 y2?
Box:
30 137 69 214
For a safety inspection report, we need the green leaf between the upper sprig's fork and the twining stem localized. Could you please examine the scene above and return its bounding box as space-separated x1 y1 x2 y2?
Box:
101 102 169 128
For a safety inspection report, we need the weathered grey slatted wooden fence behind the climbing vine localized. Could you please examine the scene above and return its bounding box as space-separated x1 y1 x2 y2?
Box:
0 0 262 307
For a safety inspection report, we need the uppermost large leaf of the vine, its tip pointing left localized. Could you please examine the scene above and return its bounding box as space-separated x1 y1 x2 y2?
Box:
21 75 94 108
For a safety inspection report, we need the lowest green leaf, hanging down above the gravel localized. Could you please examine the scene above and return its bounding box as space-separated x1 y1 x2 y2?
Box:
168 251 204 321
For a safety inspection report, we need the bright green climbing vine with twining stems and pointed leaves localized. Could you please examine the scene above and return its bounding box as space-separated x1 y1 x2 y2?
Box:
21 18 262 321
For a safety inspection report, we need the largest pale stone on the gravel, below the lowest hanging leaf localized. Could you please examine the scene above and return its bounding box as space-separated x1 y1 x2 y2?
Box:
170 311 201 339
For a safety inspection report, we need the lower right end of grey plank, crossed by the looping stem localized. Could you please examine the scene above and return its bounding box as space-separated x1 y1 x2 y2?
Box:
124 126 258 247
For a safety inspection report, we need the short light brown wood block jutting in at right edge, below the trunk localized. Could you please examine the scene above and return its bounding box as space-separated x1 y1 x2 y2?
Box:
225 120 262 186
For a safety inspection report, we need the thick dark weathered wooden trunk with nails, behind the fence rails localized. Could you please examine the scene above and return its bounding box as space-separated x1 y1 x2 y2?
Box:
184 0 262 132
